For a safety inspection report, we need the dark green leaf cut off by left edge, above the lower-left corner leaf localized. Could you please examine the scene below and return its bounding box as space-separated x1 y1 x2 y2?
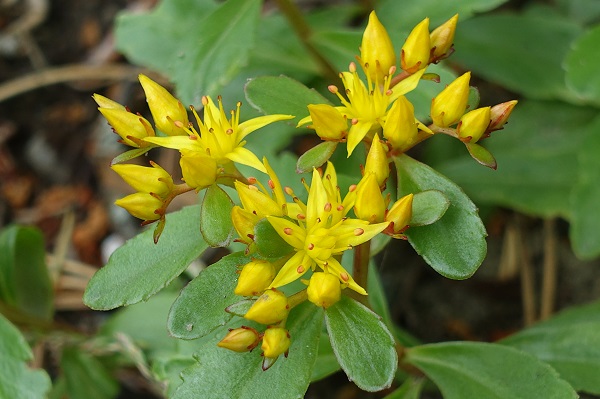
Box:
0 225 54 320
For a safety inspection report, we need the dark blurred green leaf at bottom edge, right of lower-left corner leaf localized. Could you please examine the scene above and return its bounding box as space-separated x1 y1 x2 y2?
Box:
61 348 119 399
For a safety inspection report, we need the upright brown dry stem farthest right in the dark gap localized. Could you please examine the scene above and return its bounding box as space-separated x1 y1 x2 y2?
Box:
540 219 558 320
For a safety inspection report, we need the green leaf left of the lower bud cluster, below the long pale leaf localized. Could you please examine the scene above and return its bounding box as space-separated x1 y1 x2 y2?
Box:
168 252 250 339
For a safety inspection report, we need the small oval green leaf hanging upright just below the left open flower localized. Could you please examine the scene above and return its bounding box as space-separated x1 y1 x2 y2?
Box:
200 184 234 247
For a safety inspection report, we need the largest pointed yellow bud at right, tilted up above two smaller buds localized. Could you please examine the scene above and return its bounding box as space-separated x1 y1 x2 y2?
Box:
431 72 471 127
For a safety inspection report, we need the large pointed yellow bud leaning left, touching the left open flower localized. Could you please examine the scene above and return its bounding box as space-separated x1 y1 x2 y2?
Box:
139 74 188 136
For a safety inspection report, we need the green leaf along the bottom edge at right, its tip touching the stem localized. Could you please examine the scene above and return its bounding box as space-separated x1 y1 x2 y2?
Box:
404 342 577 399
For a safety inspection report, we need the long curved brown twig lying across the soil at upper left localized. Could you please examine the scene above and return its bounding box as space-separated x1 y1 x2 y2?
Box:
0 64 143 102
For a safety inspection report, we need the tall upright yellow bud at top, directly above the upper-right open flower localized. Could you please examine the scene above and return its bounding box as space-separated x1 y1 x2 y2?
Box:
360 11 396 84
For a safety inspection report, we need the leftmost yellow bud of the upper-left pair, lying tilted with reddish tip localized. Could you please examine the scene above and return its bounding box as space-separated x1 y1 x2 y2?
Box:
98 107 154 148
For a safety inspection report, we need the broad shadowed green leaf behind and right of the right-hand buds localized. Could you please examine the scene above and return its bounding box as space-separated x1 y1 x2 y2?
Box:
430 101 598 217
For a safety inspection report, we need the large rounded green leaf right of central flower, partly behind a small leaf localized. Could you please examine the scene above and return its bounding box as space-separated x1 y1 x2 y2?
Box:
394 155 487 280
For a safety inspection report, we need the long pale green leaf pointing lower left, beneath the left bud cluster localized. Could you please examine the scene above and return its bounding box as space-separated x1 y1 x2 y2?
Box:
83 206 207 310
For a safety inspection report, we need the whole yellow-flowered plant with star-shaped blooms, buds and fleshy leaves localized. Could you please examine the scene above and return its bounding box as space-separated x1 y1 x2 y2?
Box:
79 2 584 398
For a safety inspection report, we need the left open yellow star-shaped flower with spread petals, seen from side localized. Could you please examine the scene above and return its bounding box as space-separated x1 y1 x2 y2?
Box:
146 97 293 173
